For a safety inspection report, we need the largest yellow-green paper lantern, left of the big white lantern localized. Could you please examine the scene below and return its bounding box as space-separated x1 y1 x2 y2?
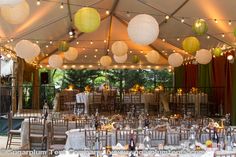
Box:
74 7 100 33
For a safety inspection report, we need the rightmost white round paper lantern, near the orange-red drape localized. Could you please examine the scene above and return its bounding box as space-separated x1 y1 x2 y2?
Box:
196 49 212 64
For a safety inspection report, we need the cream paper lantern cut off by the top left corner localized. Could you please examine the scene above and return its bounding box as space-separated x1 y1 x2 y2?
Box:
1 0 30 24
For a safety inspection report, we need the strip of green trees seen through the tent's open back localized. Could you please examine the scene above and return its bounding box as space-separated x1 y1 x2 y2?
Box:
50 69 173 91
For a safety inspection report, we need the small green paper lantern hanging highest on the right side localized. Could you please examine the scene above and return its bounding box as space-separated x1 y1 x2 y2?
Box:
192 19 208 35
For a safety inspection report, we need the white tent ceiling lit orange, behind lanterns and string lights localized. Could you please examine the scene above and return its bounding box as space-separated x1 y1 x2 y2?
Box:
0 0 236 68
